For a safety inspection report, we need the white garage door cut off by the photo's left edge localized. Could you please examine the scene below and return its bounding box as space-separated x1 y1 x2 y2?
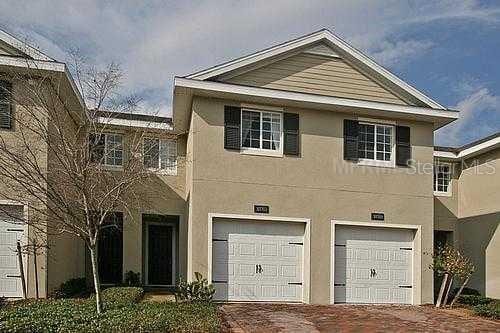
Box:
0 214 26 297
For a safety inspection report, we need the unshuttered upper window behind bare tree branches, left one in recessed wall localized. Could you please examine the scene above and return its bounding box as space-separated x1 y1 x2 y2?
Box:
90 133 123 166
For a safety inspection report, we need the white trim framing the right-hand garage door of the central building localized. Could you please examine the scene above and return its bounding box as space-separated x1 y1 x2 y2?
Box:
330 219 422 305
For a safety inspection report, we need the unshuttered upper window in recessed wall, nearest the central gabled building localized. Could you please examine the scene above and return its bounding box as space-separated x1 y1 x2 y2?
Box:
143 138 177 175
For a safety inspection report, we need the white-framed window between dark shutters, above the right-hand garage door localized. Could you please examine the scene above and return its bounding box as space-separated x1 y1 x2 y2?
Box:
358 123 394 166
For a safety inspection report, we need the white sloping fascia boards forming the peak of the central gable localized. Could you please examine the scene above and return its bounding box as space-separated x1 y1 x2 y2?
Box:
186 30 446 110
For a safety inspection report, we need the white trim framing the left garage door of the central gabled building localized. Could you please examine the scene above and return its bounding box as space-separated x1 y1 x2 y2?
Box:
207 213 311 304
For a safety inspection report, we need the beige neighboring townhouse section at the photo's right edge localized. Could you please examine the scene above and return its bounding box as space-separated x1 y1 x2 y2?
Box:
434 133 500 298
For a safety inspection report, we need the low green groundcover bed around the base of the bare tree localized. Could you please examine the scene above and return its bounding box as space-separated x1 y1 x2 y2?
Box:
0 288 219 332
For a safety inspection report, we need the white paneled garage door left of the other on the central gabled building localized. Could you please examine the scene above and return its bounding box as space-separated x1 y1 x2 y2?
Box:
212 219 304 302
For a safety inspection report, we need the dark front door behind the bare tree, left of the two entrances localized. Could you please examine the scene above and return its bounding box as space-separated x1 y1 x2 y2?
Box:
97 213 123 284
